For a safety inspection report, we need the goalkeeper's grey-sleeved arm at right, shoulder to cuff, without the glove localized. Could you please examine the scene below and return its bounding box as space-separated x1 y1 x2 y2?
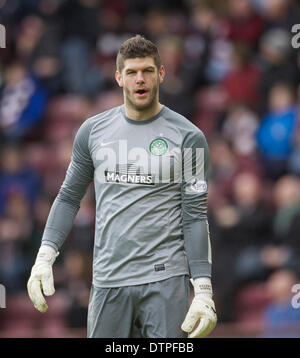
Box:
182 131 212 279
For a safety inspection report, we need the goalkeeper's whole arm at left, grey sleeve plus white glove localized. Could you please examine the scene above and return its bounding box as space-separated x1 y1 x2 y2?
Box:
27 121 94 312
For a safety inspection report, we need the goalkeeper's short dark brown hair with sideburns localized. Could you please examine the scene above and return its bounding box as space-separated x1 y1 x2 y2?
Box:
116 35 161 72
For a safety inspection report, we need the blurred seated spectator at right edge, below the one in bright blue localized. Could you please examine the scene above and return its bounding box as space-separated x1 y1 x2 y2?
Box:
235 176 300 292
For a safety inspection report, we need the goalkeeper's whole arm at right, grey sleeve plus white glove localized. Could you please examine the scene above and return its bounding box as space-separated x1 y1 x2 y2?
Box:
182 130 217 338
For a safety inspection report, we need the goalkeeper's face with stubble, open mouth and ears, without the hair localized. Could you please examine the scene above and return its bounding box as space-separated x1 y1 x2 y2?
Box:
116 57 165 111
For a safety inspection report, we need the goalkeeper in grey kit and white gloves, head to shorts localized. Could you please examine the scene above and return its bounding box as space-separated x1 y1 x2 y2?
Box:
27 35 217 338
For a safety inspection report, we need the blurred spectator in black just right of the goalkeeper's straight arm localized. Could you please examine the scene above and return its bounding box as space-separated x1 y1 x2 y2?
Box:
211 172 272 320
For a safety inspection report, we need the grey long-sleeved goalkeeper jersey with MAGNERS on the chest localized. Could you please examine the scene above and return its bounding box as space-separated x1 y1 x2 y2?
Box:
42 105 211 287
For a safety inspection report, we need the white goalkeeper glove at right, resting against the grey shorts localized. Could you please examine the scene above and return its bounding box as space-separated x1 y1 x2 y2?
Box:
181 277 217 338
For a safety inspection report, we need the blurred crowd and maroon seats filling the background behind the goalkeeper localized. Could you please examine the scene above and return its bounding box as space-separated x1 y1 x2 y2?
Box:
0 0 300 337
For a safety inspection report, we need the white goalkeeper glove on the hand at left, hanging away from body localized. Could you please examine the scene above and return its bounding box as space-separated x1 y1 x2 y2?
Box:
27 245 59 313
